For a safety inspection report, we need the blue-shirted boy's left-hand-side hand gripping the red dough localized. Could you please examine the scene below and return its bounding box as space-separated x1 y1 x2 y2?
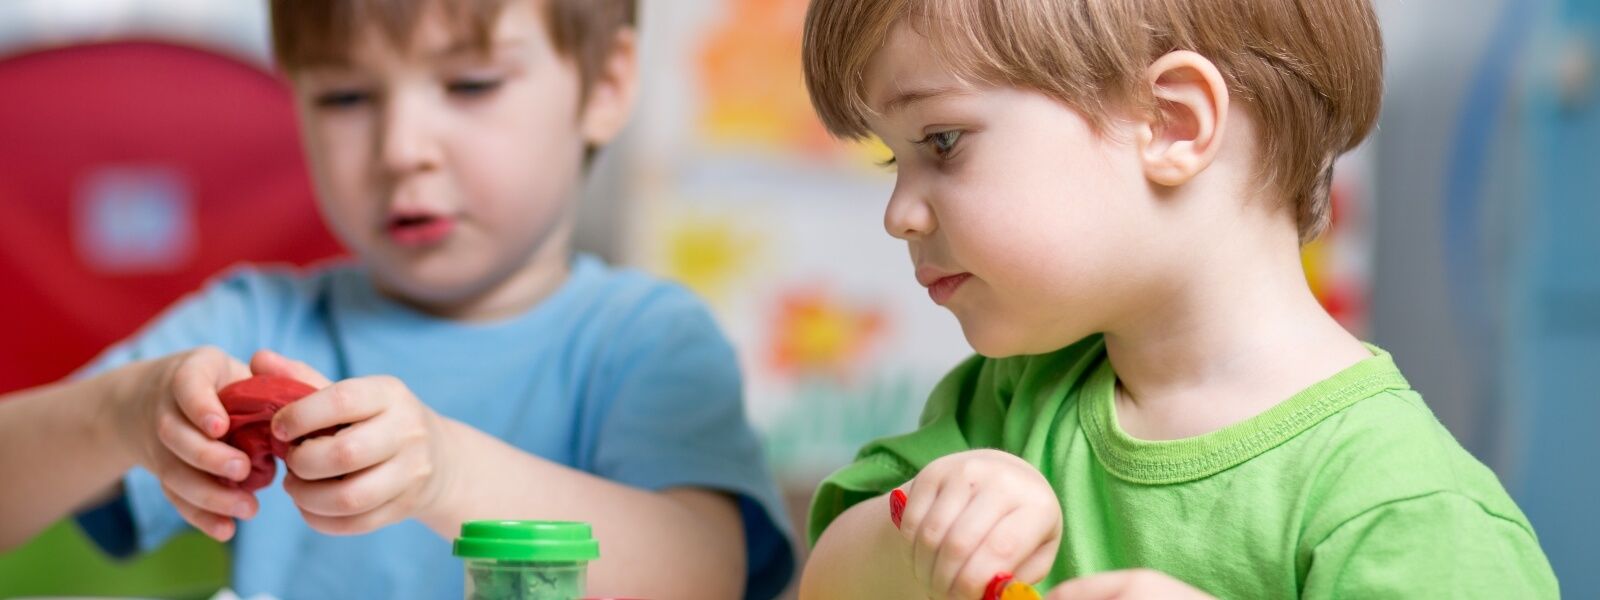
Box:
115 347 256 541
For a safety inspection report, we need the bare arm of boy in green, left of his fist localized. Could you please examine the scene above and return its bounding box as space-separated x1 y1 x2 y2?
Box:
800 494 922 600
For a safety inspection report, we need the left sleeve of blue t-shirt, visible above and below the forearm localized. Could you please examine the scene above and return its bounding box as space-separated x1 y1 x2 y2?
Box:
74 269 272 558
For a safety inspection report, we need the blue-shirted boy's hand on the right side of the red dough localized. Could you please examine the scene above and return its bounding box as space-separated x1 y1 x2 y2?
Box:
250 350 448 534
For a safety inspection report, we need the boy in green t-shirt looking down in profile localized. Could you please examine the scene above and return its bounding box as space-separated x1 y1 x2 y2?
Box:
800 0 1558 600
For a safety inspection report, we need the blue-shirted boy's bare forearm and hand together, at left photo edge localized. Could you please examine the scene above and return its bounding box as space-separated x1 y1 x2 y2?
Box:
0 349 254 550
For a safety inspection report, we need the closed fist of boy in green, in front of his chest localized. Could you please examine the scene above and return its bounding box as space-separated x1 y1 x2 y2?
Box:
901 450 1061 600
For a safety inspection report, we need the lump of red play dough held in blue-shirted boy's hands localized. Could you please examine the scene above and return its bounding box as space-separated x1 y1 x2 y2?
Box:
216 374 334 493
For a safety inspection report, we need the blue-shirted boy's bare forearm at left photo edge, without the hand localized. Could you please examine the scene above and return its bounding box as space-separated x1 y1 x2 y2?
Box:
0 363 146 552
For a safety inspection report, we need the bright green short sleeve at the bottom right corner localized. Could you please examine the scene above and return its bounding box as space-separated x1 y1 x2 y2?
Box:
1301 491 1560 598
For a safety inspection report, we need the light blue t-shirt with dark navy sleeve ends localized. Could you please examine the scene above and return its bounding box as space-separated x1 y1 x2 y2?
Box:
78 256 794 598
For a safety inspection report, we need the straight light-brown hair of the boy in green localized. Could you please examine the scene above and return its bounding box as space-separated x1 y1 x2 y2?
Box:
803 0 1382 242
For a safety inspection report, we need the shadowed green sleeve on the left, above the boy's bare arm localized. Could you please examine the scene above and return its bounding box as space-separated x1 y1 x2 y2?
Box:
806 357 1002 544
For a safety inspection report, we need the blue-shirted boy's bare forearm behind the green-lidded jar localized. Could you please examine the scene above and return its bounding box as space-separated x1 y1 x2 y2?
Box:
418 419 746 600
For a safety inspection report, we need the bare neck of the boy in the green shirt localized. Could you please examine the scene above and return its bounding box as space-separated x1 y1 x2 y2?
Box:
1106 220 1371 440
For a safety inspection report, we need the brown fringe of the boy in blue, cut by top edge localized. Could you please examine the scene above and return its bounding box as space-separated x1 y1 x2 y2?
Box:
272 0 638 96
